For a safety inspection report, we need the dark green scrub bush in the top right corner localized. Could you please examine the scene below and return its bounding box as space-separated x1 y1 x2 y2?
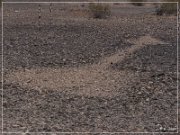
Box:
156 0 180 15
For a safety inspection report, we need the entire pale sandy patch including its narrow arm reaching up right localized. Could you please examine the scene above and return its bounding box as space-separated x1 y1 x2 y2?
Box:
5 36 165 97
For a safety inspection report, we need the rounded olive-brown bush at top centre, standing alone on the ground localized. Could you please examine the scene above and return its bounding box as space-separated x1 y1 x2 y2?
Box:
89 3 111 19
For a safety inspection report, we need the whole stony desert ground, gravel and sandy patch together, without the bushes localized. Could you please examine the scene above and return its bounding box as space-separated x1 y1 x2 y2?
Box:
1 1 178 135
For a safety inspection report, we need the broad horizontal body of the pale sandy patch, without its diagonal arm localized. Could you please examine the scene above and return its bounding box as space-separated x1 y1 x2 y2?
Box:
7 67 135 97
